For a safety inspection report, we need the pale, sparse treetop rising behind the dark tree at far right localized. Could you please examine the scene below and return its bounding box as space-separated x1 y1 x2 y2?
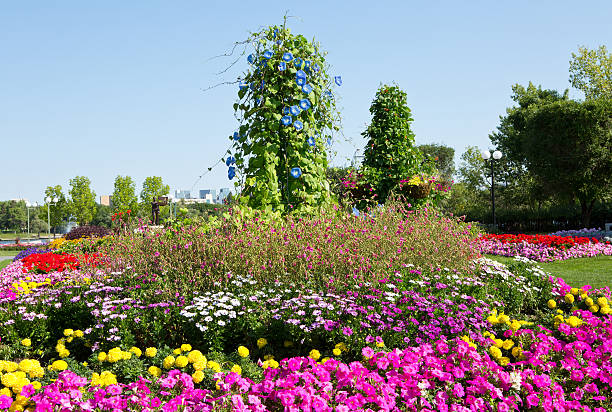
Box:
569 46 612 99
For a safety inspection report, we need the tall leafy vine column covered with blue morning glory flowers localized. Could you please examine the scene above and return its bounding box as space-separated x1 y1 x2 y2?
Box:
232 21 342 213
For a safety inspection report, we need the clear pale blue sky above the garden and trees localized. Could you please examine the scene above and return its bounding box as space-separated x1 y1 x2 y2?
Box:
0 0 612 201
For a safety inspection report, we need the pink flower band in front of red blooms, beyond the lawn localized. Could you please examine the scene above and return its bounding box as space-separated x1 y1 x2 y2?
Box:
478 238 612 262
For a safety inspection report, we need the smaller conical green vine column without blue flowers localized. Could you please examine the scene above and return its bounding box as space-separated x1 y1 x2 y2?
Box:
362 85 423 203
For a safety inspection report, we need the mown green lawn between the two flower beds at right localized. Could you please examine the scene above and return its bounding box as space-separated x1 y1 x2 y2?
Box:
486 255 612 288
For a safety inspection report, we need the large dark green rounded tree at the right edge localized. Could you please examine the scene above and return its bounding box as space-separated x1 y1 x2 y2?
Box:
521 99 612 227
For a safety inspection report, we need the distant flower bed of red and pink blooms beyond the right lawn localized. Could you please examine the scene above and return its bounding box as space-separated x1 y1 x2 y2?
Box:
478 234 612 262
